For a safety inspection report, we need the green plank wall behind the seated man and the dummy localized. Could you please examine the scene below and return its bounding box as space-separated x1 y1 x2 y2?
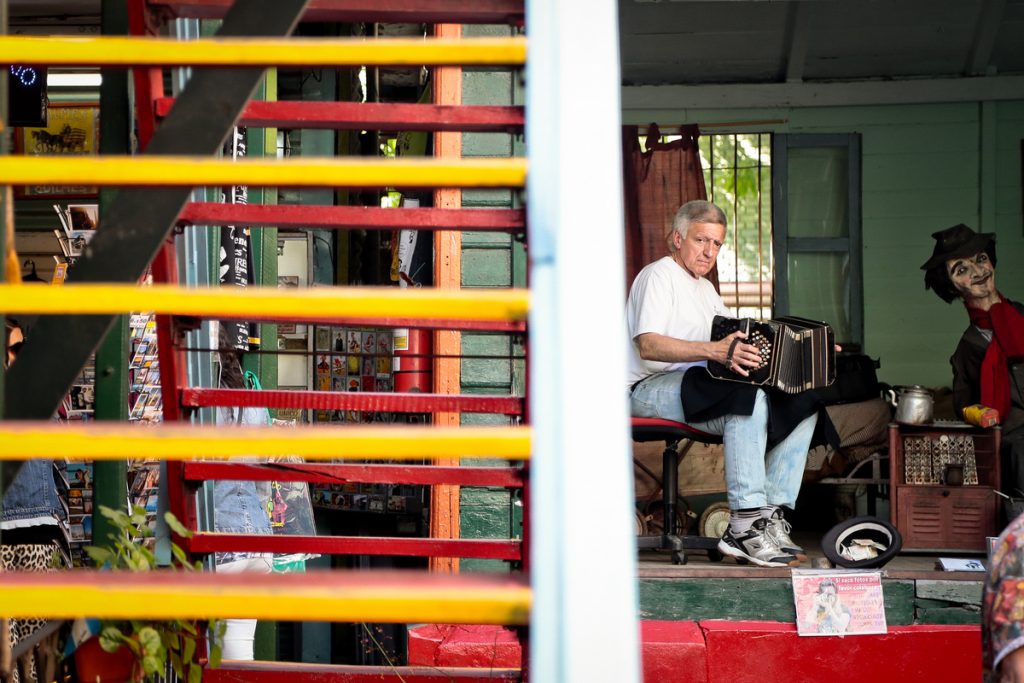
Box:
624 99 1024 387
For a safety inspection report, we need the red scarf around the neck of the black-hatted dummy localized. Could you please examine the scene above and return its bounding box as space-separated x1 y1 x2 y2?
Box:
967 294 1024 417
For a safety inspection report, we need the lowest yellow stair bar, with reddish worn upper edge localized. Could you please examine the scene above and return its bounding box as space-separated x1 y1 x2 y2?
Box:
0 570 531 625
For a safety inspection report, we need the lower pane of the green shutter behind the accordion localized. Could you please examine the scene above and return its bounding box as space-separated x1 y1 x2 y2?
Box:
788 253 853 344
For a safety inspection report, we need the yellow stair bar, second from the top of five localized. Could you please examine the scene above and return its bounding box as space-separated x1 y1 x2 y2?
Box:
0 154 526 187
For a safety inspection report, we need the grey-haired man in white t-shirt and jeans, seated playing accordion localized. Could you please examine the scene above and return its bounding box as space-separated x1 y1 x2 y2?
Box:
626 201 823 567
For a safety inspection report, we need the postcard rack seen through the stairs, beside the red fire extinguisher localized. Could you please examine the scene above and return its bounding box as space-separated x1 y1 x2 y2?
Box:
310 326 428 515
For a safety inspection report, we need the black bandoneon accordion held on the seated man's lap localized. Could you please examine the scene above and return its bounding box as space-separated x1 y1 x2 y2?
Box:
708 315 836 393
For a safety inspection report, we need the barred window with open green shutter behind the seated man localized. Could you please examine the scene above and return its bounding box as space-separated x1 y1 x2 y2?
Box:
643 133 863 350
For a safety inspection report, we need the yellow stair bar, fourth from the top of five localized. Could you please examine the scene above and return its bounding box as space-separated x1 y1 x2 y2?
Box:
0 422 532 460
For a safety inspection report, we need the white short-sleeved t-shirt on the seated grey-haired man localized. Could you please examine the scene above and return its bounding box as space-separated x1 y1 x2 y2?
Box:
626 256 731 387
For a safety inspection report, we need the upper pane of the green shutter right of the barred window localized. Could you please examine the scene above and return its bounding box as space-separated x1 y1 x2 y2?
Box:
787 146 850 239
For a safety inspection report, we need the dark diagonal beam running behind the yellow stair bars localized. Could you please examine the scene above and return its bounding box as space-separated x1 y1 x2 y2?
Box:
5 0 308 420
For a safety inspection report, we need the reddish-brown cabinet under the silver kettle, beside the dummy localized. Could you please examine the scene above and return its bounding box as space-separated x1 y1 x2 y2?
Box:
889 422 1000 552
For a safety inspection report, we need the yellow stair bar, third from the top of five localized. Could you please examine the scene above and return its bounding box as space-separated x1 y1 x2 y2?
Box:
0 286 529 323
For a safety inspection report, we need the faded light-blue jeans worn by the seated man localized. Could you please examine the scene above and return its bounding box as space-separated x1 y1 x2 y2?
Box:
630 373 817 510
